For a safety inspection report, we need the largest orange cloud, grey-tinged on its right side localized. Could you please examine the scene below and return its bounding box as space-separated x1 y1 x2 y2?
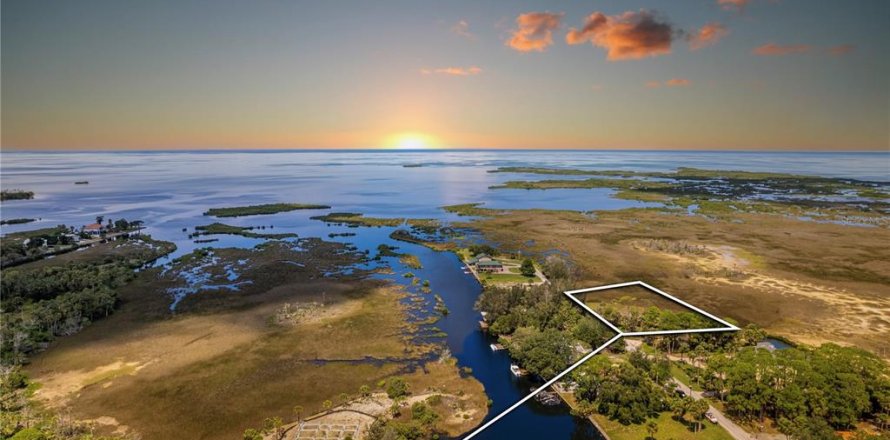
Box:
566 10 674 61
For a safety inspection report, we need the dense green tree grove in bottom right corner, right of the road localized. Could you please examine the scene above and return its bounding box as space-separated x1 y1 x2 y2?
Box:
701 344 890 439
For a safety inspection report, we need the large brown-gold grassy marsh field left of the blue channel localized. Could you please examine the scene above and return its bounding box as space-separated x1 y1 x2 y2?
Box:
27 241 486 438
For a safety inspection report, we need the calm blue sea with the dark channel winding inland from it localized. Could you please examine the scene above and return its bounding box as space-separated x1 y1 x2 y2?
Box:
0 151 890 439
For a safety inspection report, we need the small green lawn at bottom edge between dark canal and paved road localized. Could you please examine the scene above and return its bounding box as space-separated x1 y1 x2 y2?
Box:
592 412 732 440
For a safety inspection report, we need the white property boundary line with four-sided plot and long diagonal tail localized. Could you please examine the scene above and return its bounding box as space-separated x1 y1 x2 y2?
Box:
464 281 739 440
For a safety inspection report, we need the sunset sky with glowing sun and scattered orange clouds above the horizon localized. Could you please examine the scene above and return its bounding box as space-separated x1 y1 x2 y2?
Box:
2 0 890 150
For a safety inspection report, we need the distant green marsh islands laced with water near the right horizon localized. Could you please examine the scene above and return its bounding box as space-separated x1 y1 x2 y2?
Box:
490 167 890 225
